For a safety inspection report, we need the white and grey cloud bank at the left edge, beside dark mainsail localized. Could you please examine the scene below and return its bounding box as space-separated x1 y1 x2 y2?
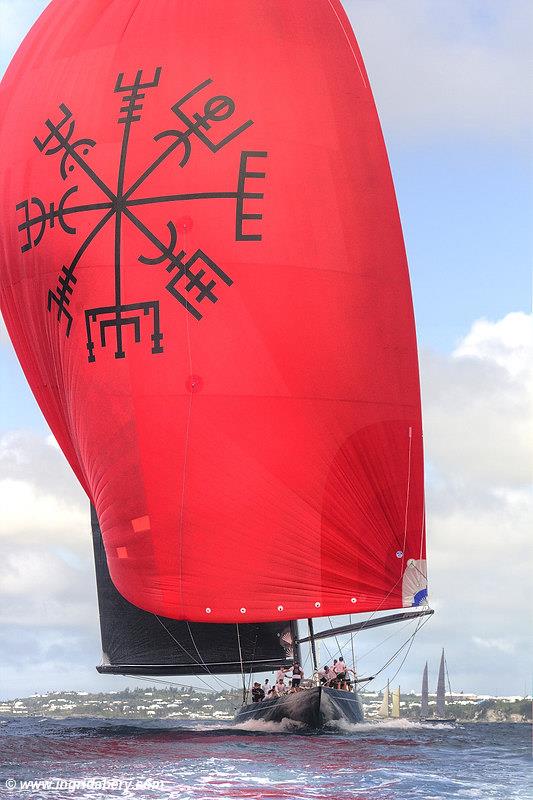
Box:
0 431 97 636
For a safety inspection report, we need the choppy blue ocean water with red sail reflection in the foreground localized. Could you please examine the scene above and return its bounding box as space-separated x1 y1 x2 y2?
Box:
0 717 533 800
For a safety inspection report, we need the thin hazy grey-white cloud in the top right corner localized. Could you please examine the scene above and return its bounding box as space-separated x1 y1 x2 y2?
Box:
344 0 533 139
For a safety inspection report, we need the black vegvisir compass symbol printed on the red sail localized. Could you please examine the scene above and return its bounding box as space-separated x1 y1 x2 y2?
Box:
16 67 267 362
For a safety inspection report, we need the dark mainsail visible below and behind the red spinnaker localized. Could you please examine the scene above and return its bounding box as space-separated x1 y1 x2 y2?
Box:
91 507 299 676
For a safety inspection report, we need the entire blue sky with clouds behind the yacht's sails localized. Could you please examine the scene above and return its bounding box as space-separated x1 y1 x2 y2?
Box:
0 0 533 697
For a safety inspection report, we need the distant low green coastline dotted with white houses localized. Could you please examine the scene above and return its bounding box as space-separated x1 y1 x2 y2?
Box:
0 687 532 722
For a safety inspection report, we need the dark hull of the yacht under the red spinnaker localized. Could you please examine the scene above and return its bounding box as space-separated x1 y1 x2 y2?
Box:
235 686 364 730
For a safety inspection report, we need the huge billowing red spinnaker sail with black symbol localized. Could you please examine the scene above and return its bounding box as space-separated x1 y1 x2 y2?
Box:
0 0 425 622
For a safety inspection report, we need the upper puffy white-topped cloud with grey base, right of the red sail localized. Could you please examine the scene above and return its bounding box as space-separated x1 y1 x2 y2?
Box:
421 313 533 488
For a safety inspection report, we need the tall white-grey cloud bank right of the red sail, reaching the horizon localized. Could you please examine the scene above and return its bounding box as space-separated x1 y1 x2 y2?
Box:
422 313 533 693
